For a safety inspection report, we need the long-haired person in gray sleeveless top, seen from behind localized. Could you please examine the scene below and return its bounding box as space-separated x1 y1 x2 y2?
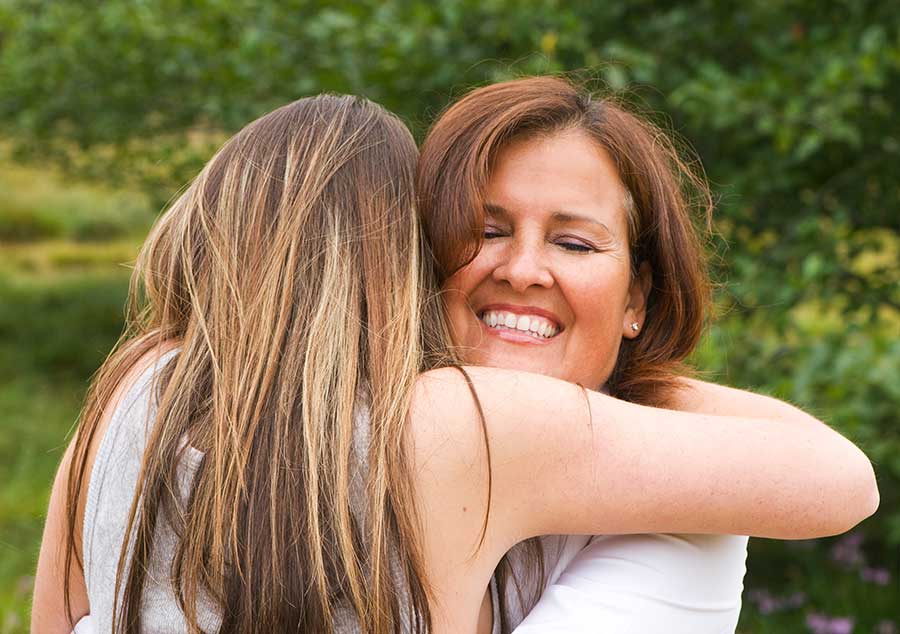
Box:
32 91 877 634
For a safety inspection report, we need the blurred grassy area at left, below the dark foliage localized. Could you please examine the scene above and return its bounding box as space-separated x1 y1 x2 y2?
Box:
0 158 147 634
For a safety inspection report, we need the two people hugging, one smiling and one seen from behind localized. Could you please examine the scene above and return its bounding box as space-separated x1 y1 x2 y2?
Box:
32 77 879 634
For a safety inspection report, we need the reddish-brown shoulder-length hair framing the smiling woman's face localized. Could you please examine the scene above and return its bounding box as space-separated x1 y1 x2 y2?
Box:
416 76 712 632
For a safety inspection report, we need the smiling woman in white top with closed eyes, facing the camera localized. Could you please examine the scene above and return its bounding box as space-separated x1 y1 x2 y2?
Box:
417 77 880 634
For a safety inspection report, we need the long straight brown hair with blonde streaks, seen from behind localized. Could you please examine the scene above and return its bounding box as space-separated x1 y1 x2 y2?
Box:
66 95 446 634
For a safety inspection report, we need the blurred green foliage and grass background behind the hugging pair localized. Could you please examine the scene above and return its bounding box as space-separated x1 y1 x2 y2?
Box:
0 0 900 632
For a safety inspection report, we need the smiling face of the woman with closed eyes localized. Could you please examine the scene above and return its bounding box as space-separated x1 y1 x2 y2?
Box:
444 130 650 389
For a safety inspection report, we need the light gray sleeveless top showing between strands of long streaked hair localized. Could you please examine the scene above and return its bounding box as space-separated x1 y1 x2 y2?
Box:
79 349 506 634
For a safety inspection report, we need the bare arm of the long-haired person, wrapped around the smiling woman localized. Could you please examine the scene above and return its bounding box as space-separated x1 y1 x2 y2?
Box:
411 367 878 547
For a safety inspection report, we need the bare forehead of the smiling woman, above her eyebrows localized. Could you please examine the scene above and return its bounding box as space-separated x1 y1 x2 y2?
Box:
485 130 628 235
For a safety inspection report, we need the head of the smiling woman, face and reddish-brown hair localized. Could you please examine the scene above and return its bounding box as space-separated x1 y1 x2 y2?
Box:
417 77 712 406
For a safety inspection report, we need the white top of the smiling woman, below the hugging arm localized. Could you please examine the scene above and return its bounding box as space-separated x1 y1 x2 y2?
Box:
502 534 748 634
